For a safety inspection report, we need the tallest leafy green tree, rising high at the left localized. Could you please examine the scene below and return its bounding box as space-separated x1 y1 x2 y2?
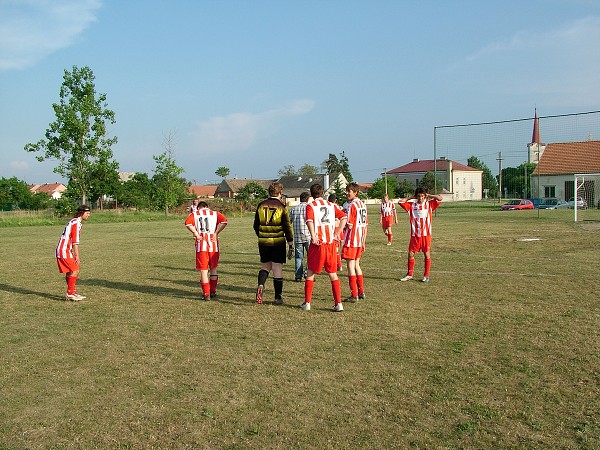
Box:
25 66 118 203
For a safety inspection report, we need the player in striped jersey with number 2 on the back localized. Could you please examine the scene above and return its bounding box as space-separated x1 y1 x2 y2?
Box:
300 184 346 312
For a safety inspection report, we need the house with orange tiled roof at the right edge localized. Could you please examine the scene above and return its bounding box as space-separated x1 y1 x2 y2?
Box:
531 141 600 205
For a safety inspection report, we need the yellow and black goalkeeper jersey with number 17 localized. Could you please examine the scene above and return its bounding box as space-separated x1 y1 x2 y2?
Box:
254 197 294 245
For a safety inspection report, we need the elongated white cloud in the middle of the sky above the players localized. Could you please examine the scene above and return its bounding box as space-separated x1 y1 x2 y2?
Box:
192 100 315 153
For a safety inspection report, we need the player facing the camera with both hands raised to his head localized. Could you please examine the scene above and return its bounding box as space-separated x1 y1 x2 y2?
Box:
398 188 442 282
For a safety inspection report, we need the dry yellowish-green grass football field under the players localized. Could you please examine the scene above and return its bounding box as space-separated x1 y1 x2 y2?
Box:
0 206 600 449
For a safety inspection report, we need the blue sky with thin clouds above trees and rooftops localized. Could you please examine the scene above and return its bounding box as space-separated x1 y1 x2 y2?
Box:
0 0 600 184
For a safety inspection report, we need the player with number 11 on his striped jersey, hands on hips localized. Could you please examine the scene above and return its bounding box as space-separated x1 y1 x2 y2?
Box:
185 202 227 300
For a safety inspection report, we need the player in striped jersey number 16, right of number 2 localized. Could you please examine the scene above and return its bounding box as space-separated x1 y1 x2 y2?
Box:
342 183 369 302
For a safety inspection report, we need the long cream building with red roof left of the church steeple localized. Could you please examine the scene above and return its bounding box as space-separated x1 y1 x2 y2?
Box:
386 157 483 201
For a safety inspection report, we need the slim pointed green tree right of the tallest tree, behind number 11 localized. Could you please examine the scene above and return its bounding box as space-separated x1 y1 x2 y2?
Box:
152 132 188 215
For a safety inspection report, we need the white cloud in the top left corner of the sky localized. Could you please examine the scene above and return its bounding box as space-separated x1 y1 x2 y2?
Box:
0 0 101 71
